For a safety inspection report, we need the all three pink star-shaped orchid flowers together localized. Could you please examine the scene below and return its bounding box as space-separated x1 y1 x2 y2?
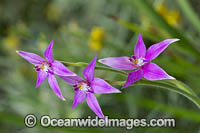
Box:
17 34 179 118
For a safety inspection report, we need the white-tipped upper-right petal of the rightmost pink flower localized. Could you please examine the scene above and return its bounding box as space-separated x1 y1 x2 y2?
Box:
145 39 179 61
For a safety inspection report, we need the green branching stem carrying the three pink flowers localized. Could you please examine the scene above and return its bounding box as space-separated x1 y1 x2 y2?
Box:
61 61 200 109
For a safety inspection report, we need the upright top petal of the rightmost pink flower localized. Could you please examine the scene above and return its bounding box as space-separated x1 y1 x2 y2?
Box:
134 34 146 58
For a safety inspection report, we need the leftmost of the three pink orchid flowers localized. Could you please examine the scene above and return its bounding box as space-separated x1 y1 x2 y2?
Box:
16 40 76 100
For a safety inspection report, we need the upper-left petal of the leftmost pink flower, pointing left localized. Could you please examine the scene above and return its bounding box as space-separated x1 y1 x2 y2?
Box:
16 51 45 65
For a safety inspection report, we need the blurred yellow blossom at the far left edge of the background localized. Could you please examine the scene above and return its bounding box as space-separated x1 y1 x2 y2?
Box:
2 34 20 52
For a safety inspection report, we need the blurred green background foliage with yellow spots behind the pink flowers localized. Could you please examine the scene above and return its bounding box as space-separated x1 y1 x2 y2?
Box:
0 0 200 133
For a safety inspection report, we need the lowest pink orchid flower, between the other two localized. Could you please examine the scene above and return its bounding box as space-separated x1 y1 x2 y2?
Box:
62 56 120 118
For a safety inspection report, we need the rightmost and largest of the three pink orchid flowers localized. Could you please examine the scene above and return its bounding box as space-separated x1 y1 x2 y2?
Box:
99 34 179 88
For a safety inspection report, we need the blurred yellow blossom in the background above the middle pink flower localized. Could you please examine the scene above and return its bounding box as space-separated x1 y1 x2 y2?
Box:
89 27 105 52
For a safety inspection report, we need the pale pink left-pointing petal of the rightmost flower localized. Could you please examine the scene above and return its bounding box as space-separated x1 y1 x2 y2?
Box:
99 56 136 70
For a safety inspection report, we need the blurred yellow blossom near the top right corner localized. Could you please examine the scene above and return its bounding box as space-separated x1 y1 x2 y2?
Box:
156 3 180 26
